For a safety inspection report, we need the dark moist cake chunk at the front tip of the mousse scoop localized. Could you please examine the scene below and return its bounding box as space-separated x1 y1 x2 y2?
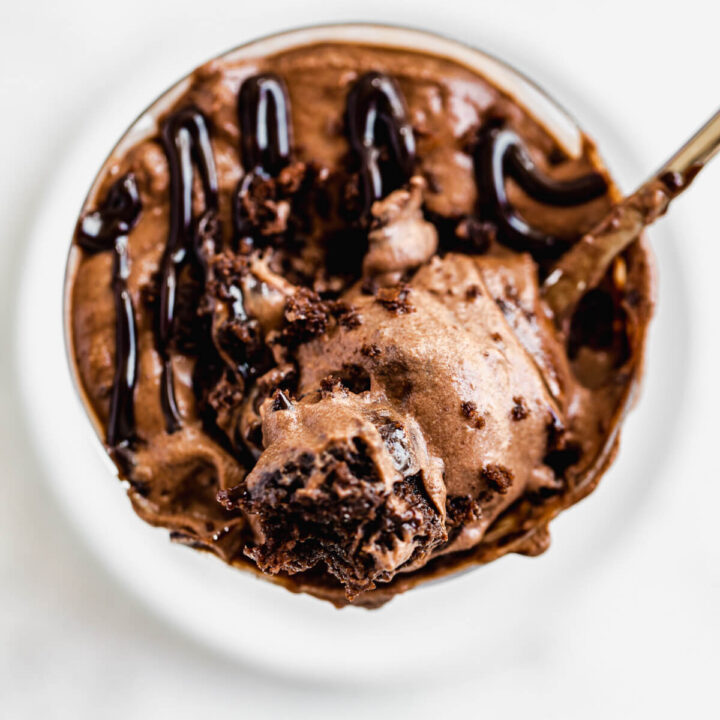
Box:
218 437 447 599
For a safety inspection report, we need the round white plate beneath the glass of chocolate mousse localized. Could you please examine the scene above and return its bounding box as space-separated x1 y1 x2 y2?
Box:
18 25 689 681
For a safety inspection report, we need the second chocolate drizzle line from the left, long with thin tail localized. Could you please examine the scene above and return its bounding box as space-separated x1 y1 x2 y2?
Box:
160 107 219 433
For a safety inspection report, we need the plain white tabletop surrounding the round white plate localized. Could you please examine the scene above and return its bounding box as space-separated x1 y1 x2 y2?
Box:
0 0 720 718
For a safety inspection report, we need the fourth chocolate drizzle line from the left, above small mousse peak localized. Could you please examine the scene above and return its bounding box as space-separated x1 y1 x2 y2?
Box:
347 72 415 215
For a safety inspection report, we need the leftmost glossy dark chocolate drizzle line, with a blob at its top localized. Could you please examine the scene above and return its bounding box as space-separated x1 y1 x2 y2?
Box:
77 174 141 448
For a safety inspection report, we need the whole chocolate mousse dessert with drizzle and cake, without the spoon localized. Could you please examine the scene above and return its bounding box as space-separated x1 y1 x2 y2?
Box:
68 43 652 607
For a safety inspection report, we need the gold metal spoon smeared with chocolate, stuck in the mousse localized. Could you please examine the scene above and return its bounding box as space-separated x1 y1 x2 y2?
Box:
542 111 720 327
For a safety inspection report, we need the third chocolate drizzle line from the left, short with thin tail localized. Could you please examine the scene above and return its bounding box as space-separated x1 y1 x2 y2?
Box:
235 73 292 245
